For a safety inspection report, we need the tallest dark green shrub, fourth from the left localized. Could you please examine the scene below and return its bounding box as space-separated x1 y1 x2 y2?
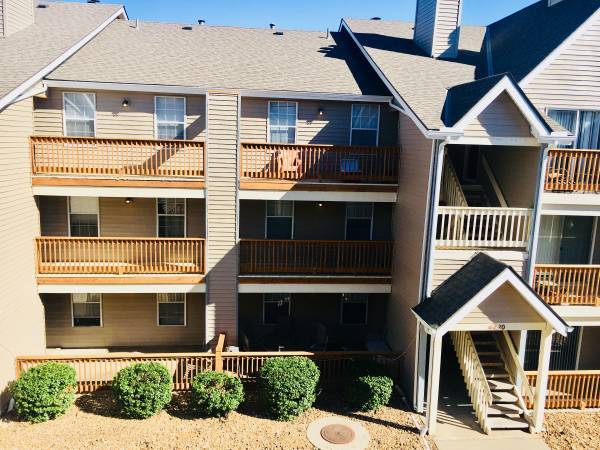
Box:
258 356 319 420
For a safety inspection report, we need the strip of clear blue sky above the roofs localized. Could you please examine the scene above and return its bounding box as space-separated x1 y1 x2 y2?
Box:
69 0 534 30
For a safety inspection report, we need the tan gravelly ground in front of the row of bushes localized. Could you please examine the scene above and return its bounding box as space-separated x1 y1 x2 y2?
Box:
0 391 423 450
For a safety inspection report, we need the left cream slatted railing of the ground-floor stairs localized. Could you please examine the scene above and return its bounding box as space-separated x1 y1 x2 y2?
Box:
450 331 493 434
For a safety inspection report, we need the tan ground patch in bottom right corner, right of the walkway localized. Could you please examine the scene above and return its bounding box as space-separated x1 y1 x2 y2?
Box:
542 412 600 450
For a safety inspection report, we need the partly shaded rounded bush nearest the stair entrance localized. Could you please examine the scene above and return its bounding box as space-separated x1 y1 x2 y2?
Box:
344 362 394 411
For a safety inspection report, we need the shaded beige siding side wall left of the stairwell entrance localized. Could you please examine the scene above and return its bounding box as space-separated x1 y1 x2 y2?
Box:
386 115 432 392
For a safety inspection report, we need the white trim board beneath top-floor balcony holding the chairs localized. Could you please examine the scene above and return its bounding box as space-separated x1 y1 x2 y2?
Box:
239 189 397 203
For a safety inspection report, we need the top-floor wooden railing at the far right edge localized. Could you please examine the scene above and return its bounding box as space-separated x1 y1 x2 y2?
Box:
545 149 600 192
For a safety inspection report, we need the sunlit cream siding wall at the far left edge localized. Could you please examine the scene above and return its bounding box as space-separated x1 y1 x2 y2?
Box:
0 99 45 408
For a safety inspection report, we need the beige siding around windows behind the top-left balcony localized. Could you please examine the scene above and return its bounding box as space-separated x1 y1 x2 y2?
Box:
34 89 206 140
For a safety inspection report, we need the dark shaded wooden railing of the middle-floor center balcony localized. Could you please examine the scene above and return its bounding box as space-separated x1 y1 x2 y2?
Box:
240 239 393 275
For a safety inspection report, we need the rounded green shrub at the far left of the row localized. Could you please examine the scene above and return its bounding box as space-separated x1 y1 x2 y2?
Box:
11 362 77 422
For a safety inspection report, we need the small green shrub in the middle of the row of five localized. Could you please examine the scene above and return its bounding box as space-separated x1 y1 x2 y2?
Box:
192 371 244 417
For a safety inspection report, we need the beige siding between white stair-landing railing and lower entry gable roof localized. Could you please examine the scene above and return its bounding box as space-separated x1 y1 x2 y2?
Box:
432 250 527 289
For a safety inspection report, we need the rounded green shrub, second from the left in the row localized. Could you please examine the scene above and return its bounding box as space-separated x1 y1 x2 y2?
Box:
112 362 173 419
